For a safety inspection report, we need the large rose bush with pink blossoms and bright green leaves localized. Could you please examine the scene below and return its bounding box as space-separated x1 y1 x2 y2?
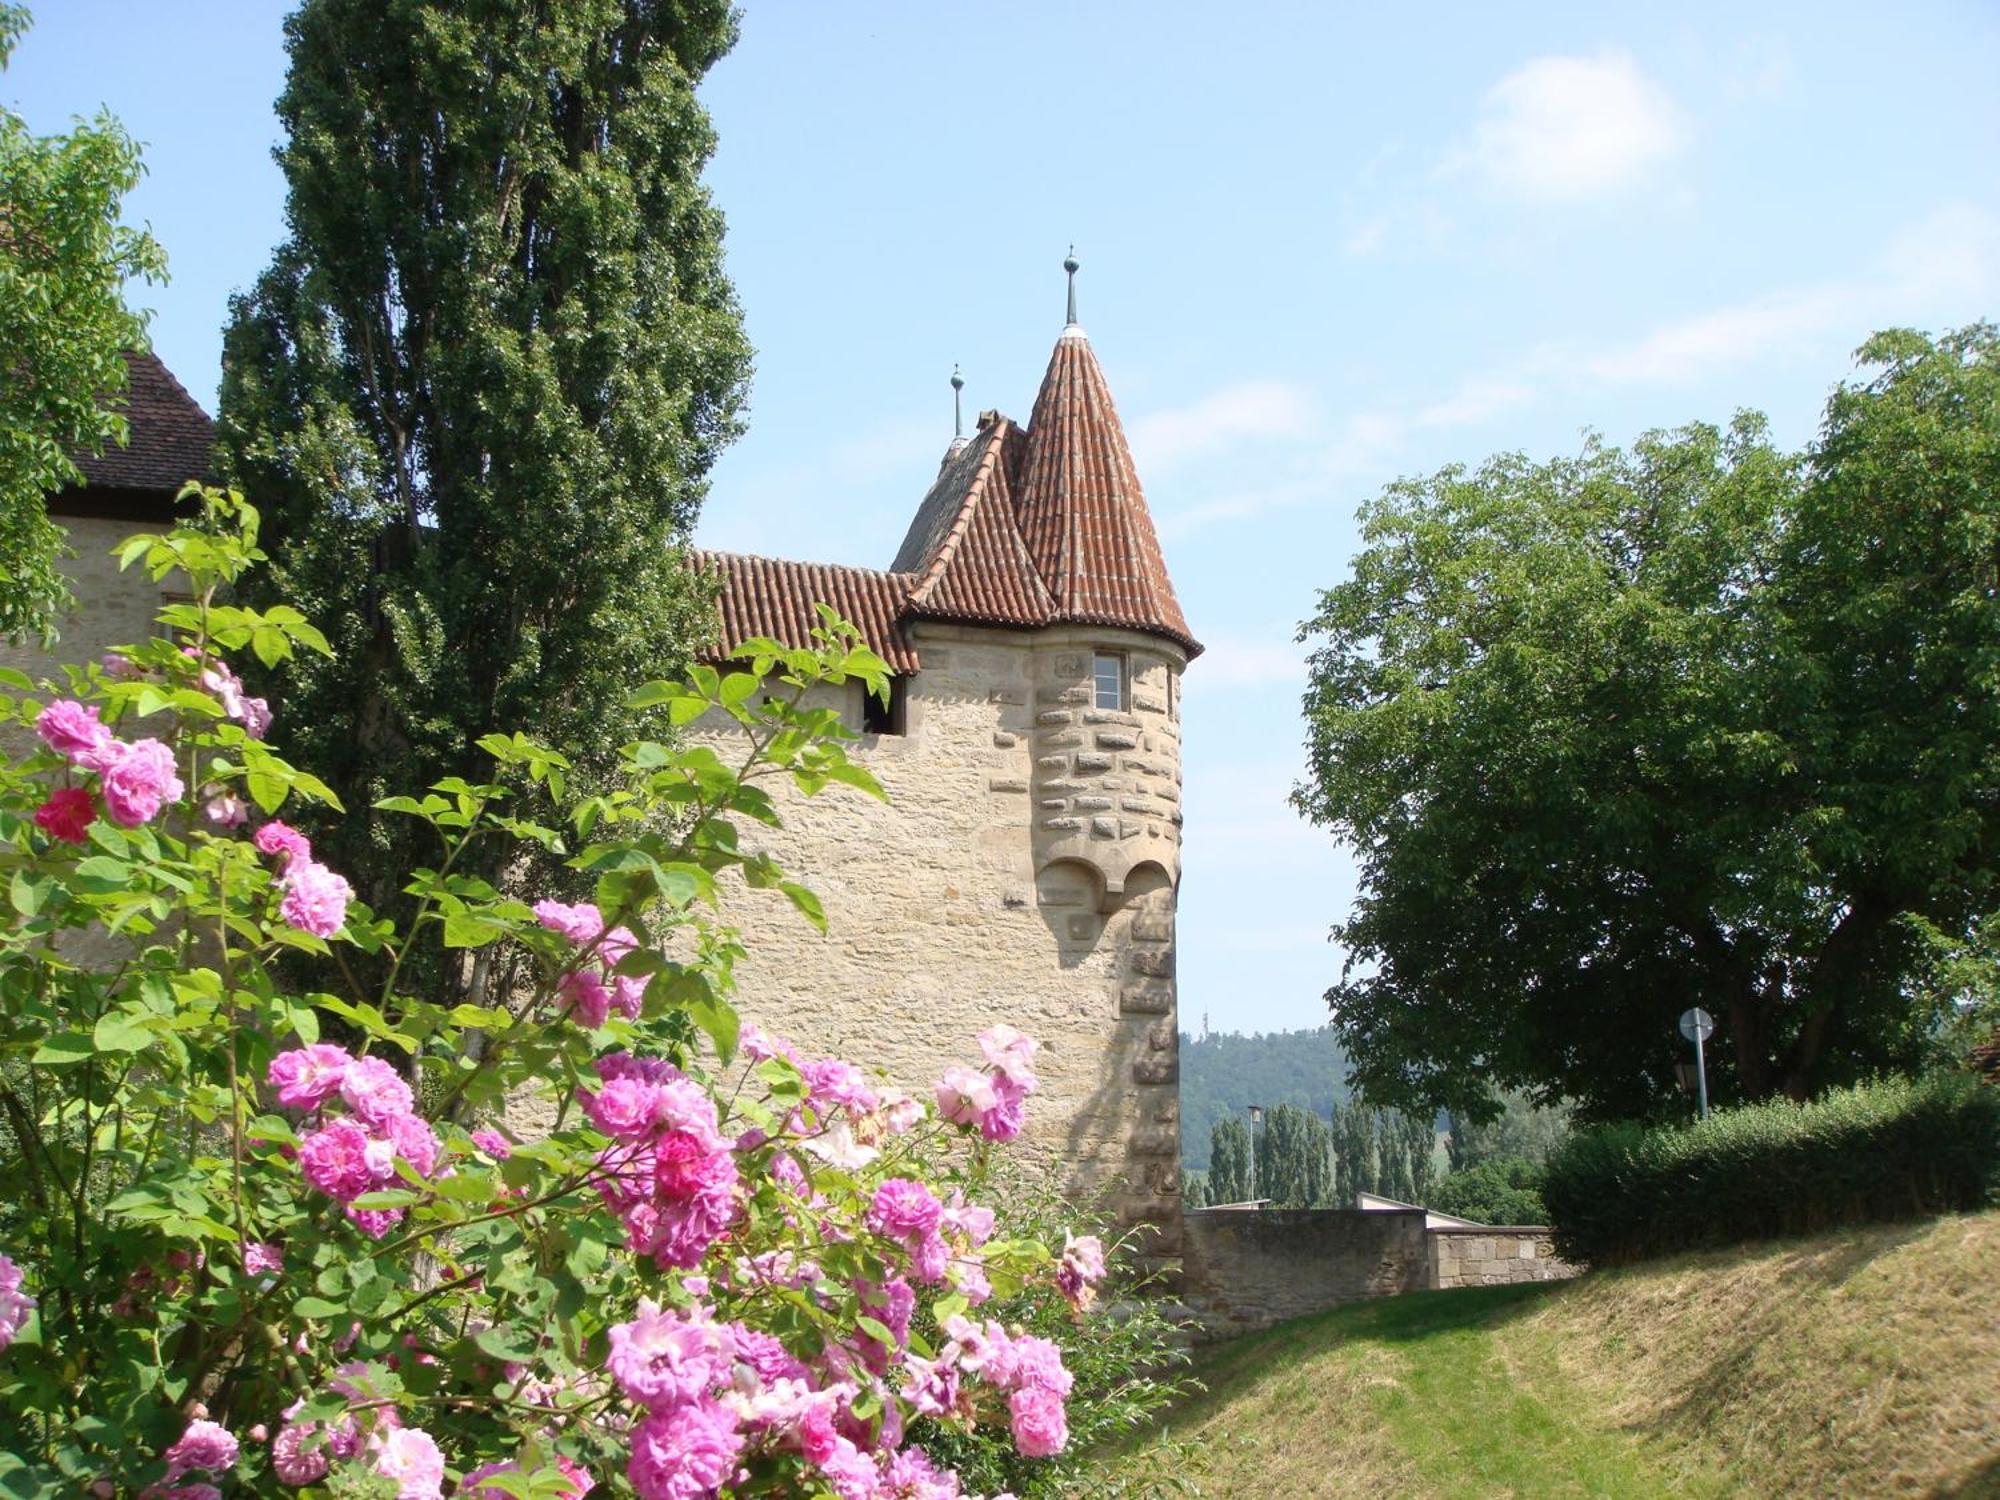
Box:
0 490 1128 1500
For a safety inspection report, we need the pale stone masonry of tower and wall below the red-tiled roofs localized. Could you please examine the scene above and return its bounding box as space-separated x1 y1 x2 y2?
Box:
696 624 1184 1254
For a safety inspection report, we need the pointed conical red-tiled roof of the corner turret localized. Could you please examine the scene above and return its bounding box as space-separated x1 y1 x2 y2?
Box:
1014 326 1200 650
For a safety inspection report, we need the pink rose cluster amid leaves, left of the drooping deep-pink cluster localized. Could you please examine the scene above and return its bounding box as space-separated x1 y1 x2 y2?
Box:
268 1042 440 1240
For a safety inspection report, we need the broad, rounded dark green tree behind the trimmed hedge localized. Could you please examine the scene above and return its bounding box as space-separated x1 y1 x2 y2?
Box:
1296 326 2000 1118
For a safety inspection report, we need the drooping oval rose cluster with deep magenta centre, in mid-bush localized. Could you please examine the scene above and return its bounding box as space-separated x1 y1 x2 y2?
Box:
576 1052 738 1270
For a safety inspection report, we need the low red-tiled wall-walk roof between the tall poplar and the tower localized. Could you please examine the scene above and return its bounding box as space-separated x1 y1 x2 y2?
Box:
688 550 918 672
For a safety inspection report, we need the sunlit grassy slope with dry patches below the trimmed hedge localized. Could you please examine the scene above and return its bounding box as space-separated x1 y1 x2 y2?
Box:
1106 1214 2000 1498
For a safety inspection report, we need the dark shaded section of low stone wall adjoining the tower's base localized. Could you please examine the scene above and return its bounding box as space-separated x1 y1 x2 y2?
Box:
1182 1208 1430 1338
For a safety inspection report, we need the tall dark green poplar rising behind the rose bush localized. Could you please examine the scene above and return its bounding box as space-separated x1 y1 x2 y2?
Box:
220 0 748 980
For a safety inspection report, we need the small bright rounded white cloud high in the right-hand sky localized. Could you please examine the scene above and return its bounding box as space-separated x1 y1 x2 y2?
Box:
1444 50 1688 200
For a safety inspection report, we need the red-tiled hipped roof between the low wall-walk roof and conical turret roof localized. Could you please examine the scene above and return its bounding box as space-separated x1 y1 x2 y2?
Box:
894 416 1056 626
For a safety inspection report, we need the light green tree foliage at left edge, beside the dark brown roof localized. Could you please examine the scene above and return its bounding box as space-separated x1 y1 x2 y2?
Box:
0 4 164 638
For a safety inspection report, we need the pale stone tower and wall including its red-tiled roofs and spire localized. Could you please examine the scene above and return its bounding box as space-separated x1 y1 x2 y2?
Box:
702 260 1200 1254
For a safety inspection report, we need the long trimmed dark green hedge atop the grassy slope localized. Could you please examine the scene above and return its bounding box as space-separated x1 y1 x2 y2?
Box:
1542 1076 2000 1266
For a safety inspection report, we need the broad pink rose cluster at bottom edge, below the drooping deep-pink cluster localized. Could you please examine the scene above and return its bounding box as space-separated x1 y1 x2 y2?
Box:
606 1278 1032 1500
